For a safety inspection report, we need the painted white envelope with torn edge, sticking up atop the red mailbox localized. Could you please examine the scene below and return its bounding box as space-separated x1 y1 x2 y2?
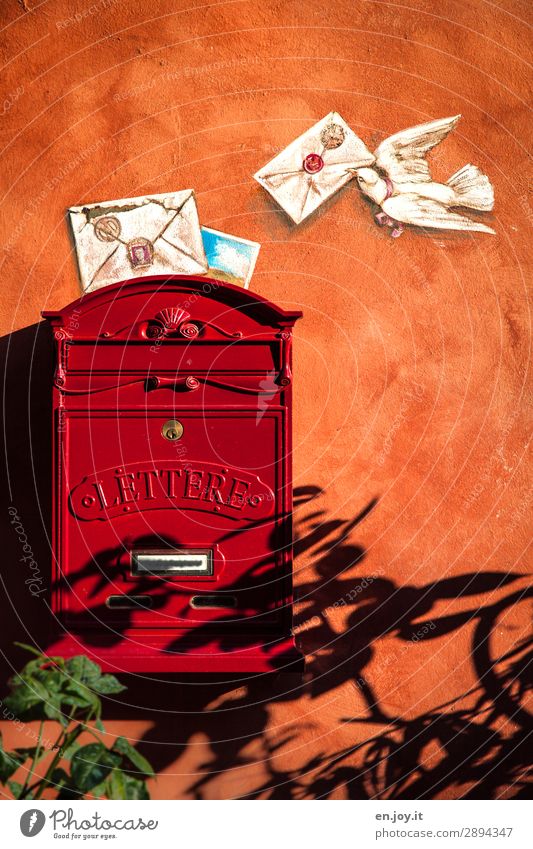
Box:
69 189 207 292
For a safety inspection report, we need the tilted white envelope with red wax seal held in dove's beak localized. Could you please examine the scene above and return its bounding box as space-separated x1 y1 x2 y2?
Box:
254 112 373 224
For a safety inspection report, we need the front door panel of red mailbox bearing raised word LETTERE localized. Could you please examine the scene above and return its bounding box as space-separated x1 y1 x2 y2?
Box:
62 408 287 629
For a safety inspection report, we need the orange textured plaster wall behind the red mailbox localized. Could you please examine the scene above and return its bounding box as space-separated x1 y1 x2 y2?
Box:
0 0 533 798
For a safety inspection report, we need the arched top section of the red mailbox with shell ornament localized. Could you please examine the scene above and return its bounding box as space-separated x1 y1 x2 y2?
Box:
43 276 301 406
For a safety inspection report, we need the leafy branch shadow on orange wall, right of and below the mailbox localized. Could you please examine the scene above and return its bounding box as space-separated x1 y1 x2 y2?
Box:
130 487 533 799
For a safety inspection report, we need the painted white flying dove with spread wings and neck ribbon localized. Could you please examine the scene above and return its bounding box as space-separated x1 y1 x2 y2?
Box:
354 115 494 238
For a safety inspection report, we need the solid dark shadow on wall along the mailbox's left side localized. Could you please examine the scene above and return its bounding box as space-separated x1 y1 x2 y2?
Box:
0 322 54 682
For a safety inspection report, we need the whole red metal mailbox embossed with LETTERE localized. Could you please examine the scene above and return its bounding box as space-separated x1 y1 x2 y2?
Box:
43 276 301 672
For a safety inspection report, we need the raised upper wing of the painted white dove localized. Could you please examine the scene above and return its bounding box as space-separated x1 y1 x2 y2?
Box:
375 115 461 183
